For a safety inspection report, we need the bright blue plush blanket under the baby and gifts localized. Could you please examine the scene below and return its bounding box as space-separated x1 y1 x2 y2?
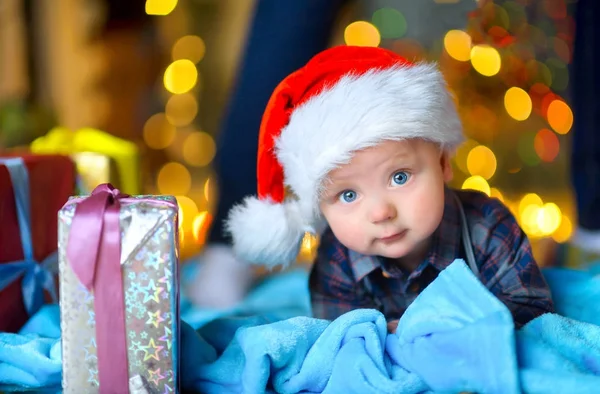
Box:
0 261 600 393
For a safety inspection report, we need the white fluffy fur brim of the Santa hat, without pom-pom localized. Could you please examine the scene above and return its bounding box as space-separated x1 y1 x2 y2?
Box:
274 63 463 220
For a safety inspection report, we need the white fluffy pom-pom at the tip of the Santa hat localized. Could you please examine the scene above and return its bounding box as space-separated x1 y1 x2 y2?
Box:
225 197 306 268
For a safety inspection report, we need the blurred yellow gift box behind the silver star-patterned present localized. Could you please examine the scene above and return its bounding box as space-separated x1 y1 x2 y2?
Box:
31 127 140 195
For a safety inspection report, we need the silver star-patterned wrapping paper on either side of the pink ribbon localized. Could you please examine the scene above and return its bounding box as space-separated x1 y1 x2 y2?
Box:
58 196 179 394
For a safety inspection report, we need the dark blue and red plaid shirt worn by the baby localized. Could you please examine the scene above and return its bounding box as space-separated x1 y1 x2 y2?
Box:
310 188 554 328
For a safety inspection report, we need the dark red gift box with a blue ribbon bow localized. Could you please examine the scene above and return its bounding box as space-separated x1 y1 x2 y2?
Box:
0 155 76 332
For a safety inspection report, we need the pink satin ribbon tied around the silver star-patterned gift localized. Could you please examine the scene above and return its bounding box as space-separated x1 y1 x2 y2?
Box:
67 184 129 394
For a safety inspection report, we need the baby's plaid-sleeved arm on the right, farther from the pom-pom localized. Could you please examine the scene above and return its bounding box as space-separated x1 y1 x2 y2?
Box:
478 203 554 328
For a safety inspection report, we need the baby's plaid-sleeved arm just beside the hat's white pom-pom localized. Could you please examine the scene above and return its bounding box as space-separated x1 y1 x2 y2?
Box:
309 233 374 320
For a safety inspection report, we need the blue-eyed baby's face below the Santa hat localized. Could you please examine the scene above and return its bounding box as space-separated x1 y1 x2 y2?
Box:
320 139 452 258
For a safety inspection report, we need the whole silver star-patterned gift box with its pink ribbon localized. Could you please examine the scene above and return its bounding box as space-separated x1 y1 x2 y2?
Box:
58 184 180 394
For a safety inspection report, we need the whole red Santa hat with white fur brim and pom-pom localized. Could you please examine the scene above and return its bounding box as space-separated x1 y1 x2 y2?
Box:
226 46 463 267
